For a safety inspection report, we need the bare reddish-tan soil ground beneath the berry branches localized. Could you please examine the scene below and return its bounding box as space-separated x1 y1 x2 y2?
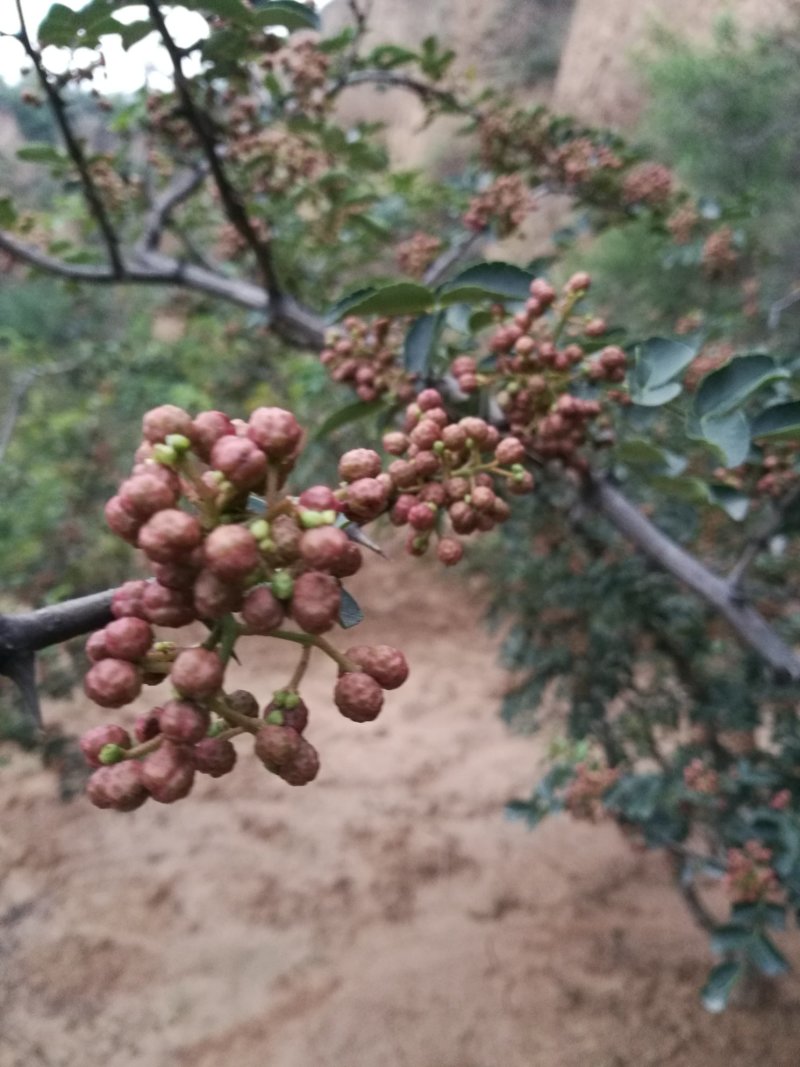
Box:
0 563 800 1067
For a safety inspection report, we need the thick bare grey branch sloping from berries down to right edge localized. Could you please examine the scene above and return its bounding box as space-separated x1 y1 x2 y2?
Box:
586 477 800 682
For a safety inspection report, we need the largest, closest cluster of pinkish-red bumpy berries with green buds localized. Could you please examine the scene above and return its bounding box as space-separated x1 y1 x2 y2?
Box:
81 404 409 811
